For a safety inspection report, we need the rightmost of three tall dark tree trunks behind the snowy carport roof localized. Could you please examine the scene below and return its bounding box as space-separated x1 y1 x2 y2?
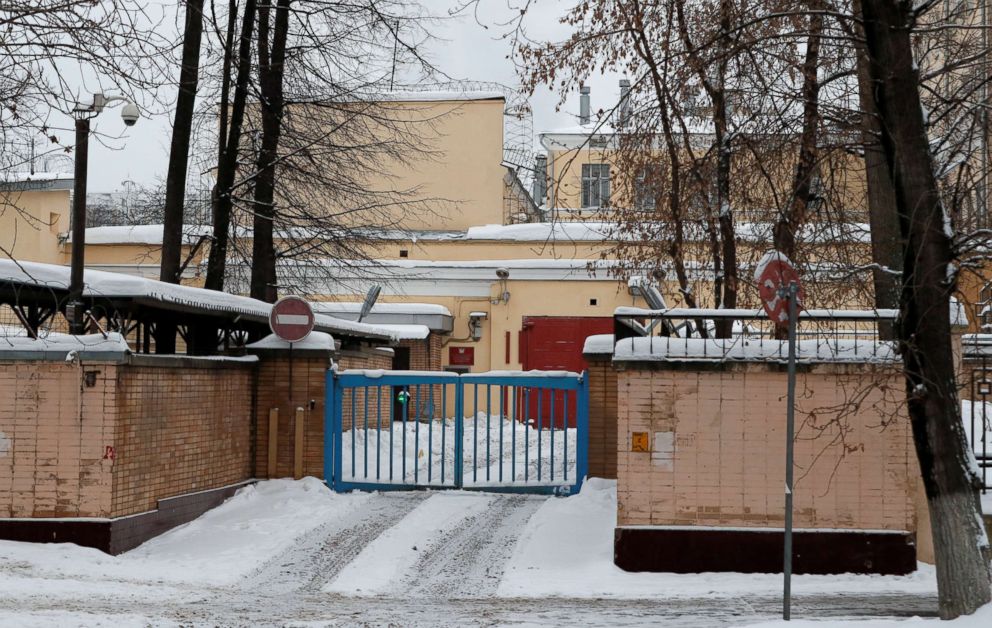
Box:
251 0 290 303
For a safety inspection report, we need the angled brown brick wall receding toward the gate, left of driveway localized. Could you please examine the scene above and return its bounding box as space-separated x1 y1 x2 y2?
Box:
112 358 254 517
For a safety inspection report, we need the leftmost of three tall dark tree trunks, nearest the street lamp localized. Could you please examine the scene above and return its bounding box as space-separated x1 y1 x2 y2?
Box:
155 0 203 353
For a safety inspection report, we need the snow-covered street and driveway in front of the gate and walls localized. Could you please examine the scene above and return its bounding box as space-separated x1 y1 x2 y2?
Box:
0 480 936 626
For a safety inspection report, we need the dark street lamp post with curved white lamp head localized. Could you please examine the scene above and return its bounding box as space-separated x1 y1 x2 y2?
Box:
65 94 140 334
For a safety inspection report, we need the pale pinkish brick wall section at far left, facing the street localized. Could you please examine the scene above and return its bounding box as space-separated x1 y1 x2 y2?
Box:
0 361 118 517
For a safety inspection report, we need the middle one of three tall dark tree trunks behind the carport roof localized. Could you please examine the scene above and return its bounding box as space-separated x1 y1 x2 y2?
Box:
204 0 256 290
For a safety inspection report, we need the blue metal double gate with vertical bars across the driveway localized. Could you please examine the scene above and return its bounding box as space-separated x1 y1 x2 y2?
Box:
324 370 589 494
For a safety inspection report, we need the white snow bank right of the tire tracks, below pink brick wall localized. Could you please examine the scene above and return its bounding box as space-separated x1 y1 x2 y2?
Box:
499 478 937 599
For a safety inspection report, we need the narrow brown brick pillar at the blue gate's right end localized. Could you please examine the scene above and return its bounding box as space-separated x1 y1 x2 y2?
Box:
584 354 617 479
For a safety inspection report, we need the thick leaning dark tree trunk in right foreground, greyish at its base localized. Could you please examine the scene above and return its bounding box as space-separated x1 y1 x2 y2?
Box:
862 0 992 619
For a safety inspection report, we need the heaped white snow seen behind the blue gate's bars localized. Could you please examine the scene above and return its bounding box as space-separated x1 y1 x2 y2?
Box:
341 411 577 486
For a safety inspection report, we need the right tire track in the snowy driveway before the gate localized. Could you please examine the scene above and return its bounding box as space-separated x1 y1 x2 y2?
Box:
406 495 548 599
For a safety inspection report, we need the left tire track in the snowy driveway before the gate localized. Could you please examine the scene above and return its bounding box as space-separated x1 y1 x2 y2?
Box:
241 492 430 594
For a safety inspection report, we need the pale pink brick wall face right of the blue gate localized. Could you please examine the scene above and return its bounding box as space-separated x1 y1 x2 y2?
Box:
617 364 918 531
